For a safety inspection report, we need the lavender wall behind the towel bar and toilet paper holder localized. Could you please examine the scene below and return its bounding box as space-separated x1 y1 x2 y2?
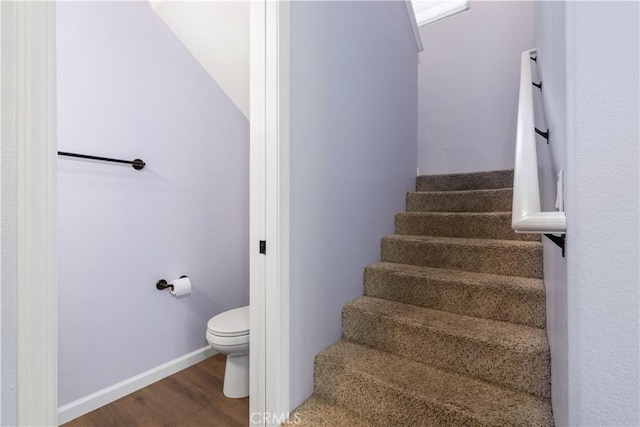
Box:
57 2 249 405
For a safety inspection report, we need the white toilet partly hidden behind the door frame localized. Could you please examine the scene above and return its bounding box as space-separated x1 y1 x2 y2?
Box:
207 305 249 398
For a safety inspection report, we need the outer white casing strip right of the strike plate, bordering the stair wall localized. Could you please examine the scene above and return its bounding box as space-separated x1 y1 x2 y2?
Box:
265 1 290 425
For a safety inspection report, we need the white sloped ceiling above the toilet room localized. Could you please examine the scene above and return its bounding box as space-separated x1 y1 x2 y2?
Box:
149 0 249 118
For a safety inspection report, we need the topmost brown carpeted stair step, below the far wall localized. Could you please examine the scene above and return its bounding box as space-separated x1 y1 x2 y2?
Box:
416 169 513 191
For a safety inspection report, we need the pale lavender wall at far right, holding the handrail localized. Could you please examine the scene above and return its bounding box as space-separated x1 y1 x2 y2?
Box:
536 2 640 426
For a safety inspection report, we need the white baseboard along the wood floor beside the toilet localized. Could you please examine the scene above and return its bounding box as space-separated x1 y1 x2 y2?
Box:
58 346 217 425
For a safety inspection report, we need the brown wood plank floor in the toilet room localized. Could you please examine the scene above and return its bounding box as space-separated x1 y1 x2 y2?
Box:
64 354 249 427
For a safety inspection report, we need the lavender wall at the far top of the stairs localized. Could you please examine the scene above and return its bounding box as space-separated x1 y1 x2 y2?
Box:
418 0 534 174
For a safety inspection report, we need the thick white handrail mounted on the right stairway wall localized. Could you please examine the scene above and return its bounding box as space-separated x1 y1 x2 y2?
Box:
511 49 567 234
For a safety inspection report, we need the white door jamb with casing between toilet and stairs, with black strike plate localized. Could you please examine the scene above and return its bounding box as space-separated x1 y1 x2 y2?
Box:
249 1 290 426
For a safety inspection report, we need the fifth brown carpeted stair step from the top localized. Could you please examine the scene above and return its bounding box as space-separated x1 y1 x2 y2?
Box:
364 262 546 328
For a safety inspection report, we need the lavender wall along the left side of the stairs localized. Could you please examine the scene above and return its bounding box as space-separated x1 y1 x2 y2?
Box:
290 1 417 407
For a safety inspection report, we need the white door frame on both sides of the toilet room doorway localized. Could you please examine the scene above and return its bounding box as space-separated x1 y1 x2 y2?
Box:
5 0 289 426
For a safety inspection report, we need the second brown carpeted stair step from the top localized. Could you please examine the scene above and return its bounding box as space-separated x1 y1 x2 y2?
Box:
406 188 513 212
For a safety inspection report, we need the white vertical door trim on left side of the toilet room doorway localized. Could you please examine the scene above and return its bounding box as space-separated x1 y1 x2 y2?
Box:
16 2 58 425
